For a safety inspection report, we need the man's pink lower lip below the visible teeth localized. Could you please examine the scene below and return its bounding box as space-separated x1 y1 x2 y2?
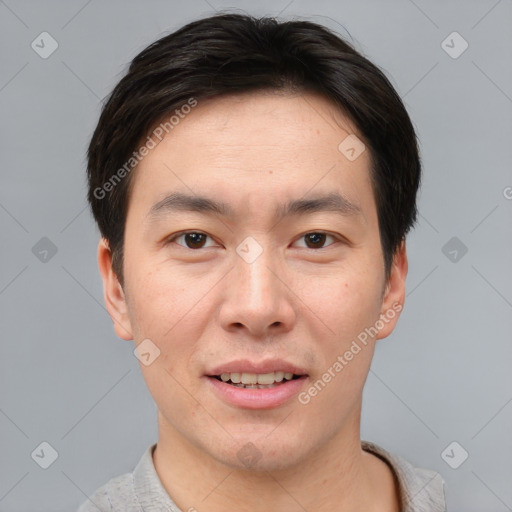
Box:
207 375 307 409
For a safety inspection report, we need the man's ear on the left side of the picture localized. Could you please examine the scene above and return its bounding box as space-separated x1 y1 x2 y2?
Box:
98 238 133 341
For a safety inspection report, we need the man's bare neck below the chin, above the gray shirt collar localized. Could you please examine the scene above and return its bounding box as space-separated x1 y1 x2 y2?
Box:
153 409 399 512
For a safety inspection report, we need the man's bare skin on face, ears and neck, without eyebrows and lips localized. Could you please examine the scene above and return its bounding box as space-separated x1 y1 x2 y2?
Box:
98 92 407 512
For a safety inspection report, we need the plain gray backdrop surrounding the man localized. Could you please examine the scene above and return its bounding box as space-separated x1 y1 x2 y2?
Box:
0 0 512 512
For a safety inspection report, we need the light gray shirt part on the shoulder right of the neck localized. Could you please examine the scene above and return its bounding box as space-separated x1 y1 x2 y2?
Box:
361 441 446 512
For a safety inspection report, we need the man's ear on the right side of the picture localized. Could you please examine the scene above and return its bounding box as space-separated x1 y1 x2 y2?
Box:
377 240 408 339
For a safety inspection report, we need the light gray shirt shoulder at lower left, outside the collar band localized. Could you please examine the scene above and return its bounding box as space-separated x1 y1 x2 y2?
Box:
77 473 142 512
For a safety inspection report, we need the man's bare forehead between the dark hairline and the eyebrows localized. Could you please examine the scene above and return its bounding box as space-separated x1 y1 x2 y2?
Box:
126 92 371 219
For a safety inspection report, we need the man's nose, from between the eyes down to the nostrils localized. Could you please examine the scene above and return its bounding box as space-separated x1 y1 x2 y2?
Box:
220 243 296 337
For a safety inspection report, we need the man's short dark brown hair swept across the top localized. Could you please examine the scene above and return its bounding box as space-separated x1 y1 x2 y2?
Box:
87 14 421 285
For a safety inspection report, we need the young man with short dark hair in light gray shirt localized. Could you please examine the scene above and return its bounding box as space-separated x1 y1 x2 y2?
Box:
80 14 445 512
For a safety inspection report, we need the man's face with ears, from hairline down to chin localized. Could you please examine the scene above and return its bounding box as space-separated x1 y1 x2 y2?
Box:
99 93 407 470
